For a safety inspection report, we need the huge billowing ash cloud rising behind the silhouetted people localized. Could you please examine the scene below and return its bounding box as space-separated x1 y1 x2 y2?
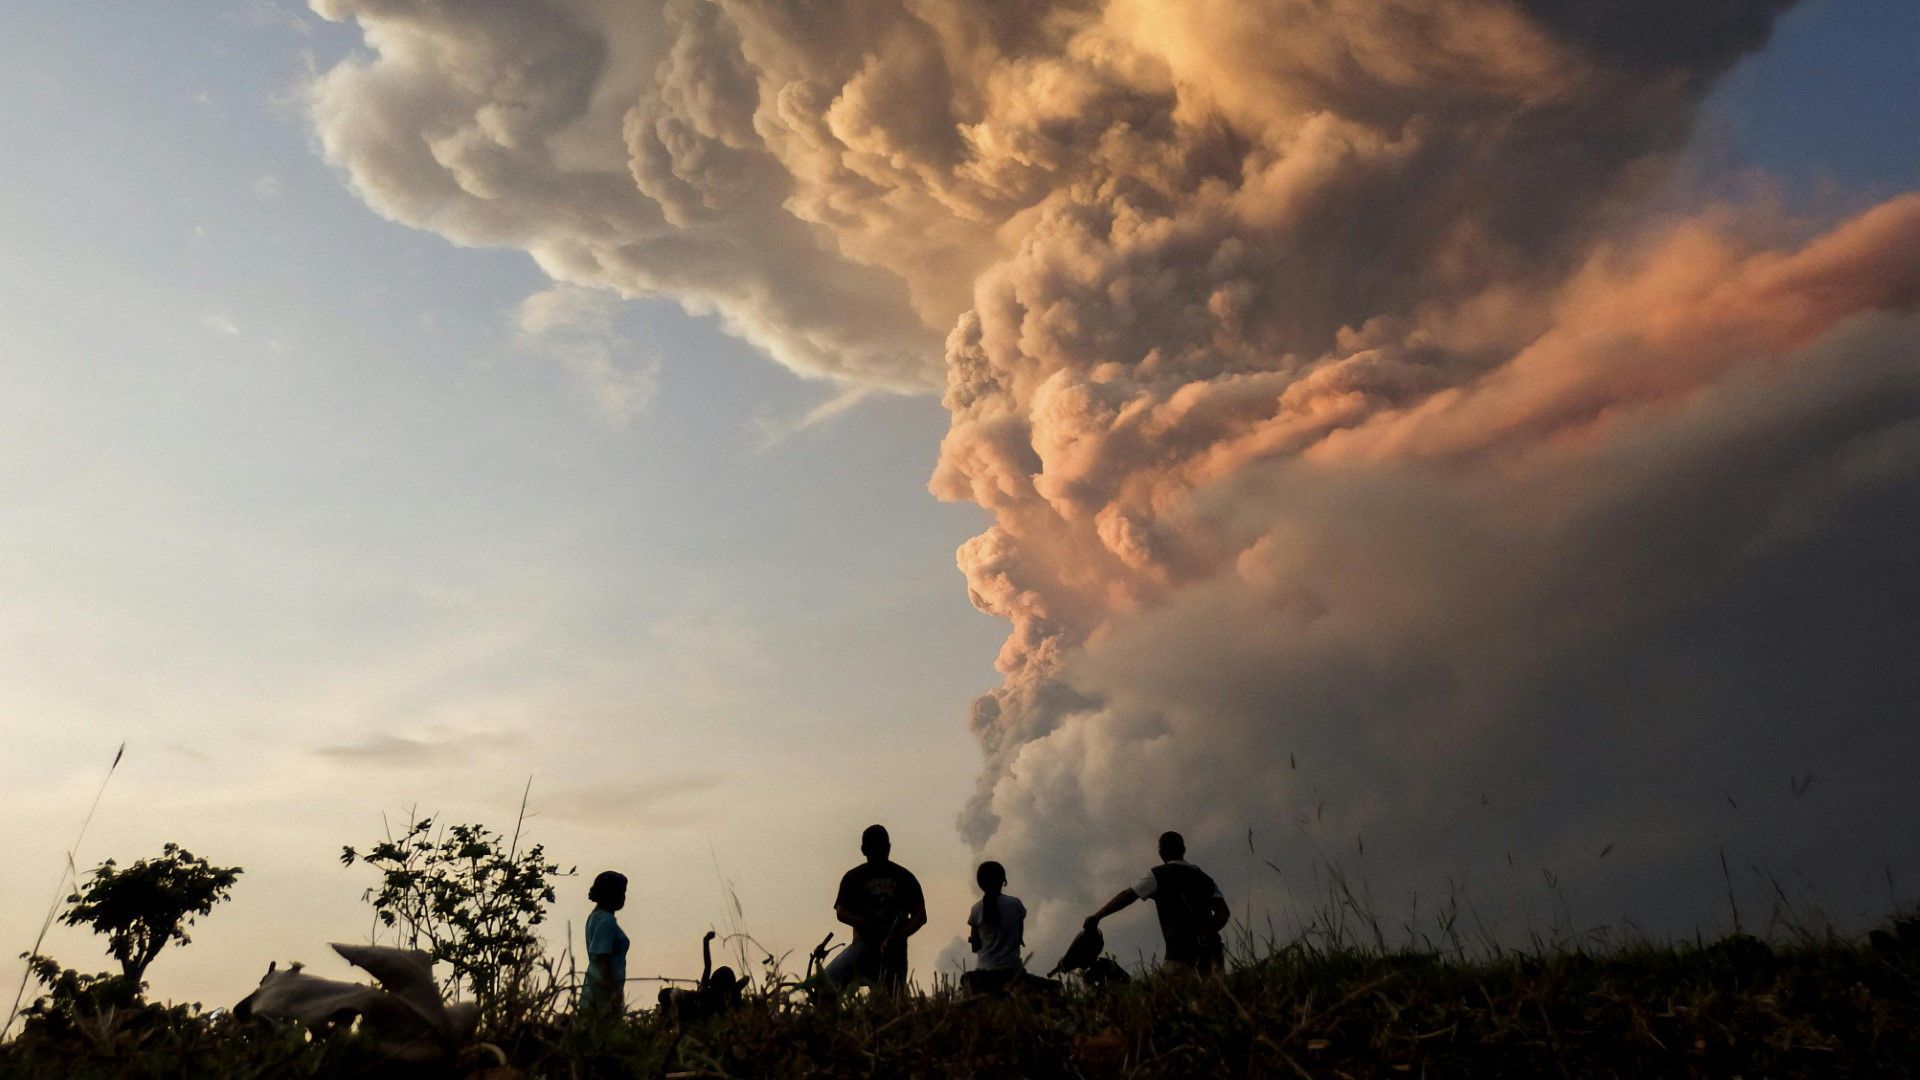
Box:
313 0 1920 930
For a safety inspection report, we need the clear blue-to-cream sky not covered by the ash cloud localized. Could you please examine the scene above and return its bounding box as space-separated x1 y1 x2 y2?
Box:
0 0 1920 1001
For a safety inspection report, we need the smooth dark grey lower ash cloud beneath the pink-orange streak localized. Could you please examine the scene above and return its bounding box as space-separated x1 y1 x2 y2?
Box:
987 319 1920 949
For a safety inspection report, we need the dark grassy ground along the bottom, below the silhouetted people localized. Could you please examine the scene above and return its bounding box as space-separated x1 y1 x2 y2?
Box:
0 914 1920 1080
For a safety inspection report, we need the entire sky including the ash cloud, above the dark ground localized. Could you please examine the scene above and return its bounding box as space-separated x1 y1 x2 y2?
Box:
0 0 1920 1003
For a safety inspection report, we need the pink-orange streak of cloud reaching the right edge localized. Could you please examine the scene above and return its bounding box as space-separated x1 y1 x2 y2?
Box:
1315 194 1920 459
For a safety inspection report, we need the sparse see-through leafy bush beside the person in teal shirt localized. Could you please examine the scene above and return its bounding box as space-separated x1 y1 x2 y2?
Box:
340 817 572 1005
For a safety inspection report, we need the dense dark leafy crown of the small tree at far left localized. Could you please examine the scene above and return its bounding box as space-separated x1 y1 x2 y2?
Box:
61 844 240 986
